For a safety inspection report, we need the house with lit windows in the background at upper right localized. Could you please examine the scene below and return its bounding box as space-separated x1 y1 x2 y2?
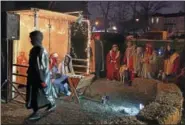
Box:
149 11 185 35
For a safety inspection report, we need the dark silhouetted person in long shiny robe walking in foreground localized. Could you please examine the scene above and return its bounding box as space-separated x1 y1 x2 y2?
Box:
26 31 57 120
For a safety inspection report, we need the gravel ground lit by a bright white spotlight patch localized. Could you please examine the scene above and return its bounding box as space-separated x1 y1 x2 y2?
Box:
1 79 158 124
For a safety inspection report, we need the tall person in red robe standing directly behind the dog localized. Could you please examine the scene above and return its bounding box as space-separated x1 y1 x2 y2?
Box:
123 40 135 80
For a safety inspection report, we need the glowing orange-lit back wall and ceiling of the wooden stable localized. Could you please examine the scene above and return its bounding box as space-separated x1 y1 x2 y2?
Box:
13 10 78 84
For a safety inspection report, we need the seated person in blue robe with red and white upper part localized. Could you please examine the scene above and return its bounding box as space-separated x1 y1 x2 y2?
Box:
50 53 71 96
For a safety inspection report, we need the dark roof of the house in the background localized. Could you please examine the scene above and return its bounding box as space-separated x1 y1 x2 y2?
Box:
152 11 185 17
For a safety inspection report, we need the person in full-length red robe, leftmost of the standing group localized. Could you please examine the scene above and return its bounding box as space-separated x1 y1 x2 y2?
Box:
106 45 120 80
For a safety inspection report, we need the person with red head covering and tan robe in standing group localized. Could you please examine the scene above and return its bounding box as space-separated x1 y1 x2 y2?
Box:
142 43 153 79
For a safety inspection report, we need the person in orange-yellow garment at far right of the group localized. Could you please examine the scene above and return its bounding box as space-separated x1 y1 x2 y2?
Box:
164 44 180 76
